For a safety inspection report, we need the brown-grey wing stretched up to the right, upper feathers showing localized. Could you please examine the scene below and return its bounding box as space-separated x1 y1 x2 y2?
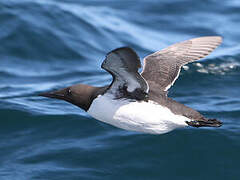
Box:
141 36 222 92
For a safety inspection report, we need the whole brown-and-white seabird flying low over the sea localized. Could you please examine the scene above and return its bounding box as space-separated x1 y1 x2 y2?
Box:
40 36 222 134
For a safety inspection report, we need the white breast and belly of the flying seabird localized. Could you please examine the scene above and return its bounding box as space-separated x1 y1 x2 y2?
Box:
87 94 190 134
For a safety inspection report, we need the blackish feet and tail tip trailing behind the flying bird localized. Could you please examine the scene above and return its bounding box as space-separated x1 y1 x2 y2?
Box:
186 118 222 127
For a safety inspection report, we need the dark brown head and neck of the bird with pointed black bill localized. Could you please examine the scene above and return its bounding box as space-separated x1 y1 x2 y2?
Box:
39 84 107 111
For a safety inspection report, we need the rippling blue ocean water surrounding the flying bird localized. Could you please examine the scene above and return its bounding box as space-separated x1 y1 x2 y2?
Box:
0 0 240 180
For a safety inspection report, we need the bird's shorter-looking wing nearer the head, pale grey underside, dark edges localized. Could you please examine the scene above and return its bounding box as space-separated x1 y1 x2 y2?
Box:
101 47 149 100
